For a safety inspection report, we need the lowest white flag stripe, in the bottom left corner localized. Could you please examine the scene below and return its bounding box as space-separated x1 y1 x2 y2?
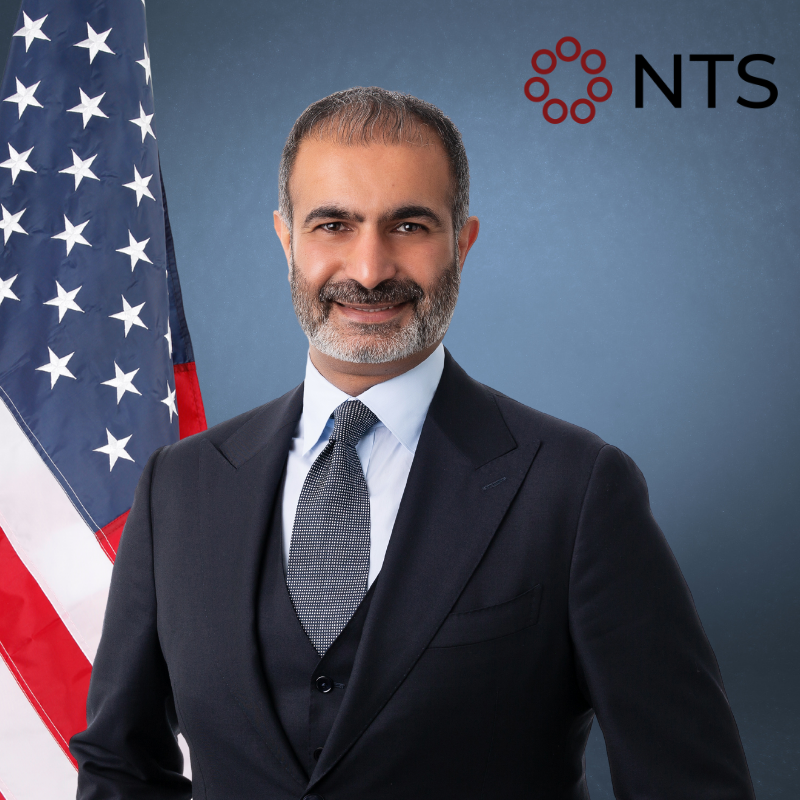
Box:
0 659 78 800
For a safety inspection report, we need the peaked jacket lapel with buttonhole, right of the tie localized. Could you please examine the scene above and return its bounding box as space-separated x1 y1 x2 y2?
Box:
309 353 539 789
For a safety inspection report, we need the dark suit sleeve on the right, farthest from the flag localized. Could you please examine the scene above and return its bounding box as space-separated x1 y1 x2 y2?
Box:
569 445 754 800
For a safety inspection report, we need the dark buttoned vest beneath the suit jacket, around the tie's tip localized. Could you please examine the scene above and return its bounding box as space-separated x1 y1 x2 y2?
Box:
257 478 375 777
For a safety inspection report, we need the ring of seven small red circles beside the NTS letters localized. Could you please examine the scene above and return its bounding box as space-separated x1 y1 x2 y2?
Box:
525 36 612 125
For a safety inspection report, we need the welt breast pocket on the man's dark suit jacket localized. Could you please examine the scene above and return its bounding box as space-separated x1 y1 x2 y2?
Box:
429 584 542 647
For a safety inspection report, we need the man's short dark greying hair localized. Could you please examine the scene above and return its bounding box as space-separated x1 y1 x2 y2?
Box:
278 86 469 236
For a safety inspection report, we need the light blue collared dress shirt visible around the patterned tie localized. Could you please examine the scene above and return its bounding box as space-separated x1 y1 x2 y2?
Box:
282 344 444 586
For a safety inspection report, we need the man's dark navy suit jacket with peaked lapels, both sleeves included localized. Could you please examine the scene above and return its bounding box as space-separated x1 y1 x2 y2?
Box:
71 354 753 800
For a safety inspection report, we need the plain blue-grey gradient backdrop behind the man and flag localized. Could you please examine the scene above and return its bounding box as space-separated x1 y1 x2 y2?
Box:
0 0 800 800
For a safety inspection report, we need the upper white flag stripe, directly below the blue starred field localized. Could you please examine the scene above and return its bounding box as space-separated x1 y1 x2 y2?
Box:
0 400 111 661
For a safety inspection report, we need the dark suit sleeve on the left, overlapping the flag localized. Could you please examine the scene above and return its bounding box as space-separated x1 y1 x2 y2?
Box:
70 451 192 800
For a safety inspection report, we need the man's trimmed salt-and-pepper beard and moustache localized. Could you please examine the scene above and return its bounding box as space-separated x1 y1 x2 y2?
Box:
289 251 461 364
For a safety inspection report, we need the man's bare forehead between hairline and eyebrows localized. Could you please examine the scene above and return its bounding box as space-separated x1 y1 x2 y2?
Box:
289 136 453 213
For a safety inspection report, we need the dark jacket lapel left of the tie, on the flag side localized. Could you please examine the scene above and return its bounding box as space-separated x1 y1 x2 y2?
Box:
197 386 307 786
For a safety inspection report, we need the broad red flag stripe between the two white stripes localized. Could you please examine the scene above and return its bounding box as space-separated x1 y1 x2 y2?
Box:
0 528 92 766
